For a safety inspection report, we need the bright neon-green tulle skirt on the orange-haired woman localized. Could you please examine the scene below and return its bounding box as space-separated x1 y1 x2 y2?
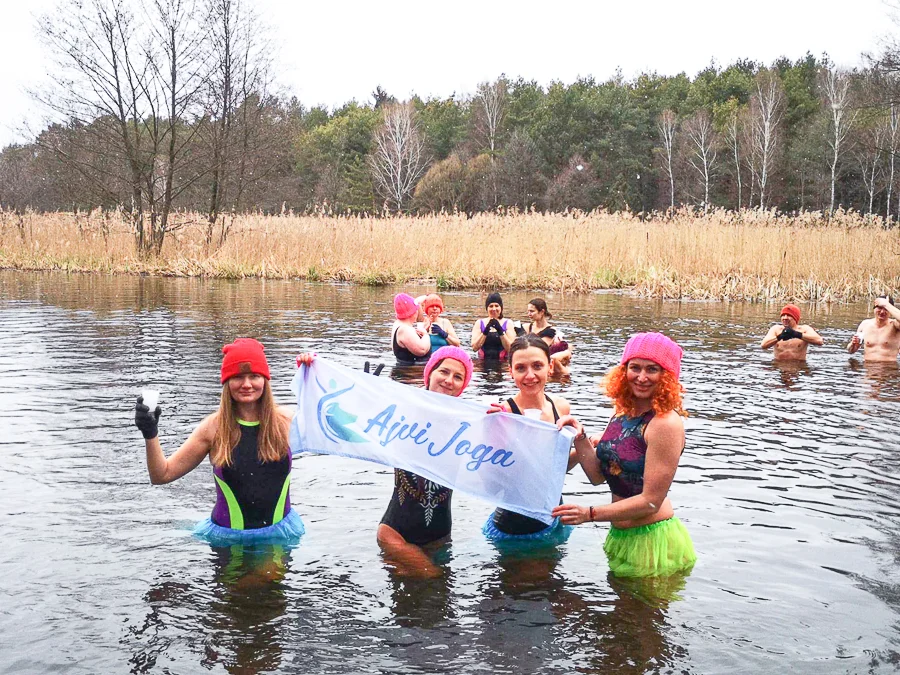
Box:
603 516 697 577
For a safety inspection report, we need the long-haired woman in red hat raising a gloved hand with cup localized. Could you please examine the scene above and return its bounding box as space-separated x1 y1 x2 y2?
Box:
134 338 304 544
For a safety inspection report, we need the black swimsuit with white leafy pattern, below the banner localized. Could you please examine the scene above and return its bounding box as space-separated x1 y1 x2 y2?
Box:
381 469 453 546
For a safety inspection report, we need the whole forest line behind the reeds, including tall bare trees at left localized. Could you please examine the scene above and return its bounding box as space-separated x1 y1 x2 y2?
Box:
0 0 900 251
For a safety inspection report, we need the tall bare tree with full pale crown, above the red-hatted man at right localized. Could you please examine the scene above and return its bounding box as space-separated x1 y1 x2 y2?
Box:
750 70 784 209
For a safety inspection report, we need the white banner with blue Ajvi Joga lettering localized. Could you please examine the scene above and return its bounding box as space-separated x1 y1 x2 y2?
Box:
290 358 574 524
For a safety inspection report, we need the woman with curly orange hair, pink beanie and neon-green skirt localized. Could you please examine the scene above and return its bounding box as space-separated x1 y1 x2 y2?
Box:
553 333 697 577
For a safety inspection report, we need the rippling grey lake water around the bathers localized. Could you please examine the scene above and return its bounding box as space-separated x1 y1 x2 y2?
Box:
0 272 900 674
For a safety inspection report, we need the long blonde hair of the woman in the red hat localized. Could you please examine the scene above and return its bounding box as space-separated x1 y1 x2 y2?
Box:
209 380 290 466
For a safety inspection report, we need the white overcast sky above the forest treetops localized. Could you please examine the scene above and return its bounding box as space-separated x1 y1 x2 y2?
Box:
0 0 900 145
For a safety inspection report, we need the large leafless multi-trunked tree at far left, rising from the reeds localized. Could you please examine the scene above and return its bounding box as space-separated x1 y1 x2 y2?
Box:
35 0 205 253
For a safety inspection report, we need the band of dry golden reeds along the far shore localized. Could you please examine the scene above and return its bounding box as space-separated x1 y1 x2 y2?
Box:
0 206 900 302
